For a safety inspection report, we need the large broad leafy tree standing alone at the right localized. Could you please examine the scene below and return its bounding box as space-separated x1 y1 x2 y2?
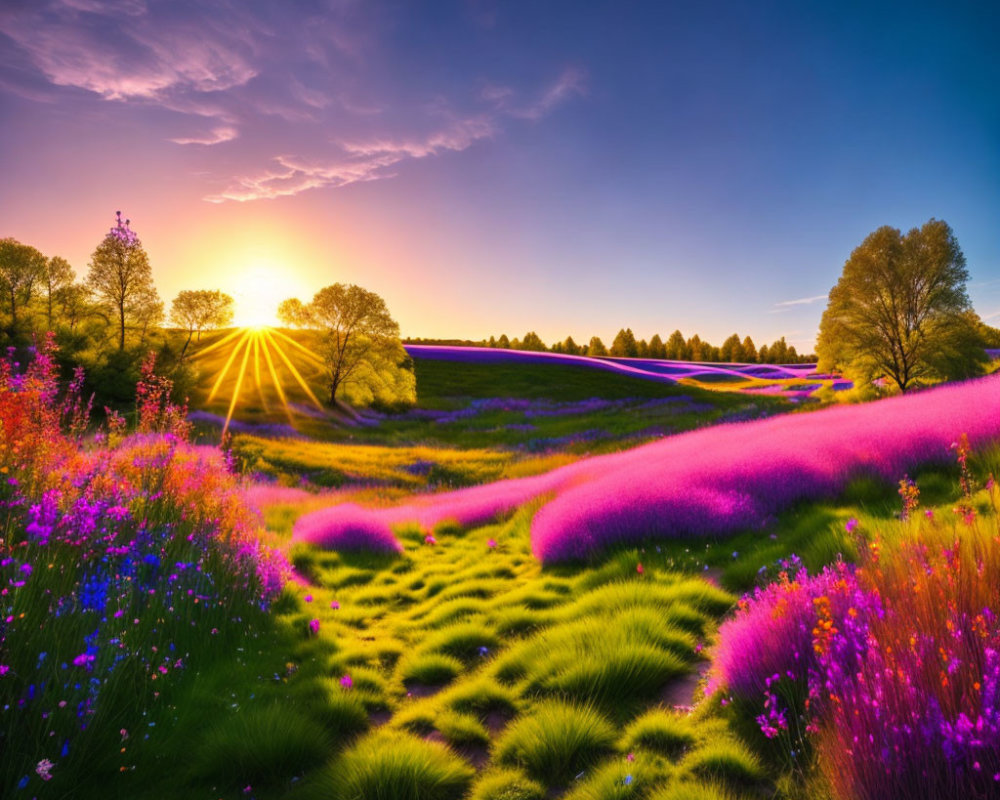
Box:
816 219 985 392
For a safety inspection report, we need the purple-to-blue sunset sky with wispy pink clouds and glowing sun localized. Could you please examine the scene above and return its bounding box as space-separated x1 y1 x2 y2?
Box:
0 0 1000 351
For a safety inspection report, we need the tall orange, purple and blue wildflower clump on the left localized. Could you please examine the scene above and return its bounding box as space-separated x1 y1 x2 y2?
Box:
0 343 287 797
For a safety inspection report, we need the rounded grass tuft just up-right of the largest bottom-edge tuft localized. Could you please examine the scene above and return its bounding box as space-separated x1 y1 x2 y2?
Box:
496 700 615 785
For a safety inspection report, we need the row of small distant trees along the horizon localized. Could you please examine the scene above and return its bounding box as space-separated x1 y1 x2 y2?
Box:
410 328 815 364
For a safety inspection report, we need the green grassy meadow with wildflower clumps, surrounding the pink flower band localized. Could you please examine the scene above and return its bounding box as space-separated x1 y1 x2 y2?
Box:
0 334 1000 800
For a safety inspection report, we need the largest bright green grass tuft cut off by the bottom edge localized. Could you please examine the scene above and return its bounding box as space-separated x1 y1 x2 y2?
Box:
317 731 475 800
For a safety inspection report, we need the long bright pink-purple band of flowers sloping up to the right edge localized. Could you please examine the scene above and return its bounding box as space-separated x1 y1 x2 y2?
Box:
294 376 1000 562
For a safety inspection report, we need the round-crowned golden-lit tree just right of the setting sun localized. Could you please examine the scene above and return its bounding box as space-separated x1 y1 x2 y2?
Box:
279 283 401 405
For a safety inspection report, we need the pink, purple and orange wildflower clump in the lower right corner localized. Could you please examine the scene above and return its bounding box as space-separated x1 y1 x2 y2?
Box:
710 454 1000 800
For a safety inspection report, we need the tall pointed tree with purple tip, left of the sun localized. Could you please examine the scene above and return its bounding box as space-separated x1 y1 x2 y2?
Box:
87 211 156 351
